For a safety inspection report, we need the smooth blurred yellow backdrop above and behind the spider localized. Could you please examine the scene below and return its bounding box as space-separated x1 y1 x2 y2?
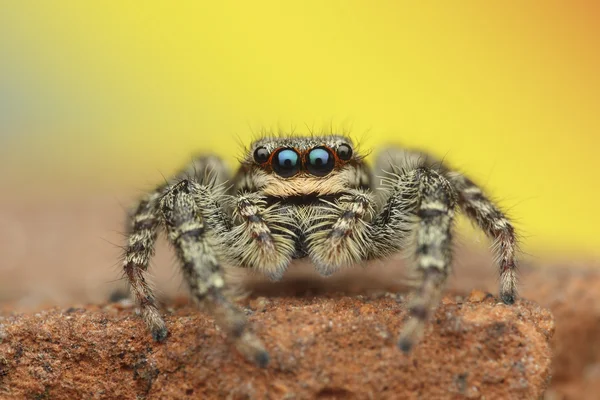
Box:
0 0 600 255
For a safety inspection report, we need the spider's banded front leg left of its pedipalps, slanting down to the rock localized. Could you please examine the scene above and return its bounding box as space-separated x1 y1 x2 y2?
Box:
160 180 269 366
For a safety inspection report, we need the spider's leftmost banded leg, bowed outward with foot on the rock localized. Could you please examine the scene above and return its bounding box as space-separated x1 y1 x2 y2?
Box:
123 156 228 341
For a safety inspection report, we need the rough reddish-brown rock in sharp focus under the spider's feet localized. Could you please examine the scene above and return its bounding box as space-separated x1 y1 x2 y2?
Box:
0 292 554 399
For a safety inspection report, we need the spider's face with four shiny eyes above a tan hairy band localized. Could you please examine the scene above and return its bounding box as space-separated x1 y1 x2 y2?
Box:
244 135 369 197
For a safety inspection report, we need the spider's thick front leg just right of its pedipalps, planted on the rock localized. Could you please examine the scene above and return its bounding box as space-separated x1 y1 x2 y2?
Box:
371 167 456 352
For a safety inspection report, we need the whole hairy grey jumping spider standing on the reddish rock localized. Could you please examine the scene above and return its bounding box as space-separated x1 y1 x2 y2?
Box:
124 135 516 366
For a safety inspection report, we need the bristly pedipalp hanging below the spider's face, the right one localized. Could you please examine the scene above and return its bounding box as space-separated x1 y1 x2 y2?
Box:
307 190 373 276
